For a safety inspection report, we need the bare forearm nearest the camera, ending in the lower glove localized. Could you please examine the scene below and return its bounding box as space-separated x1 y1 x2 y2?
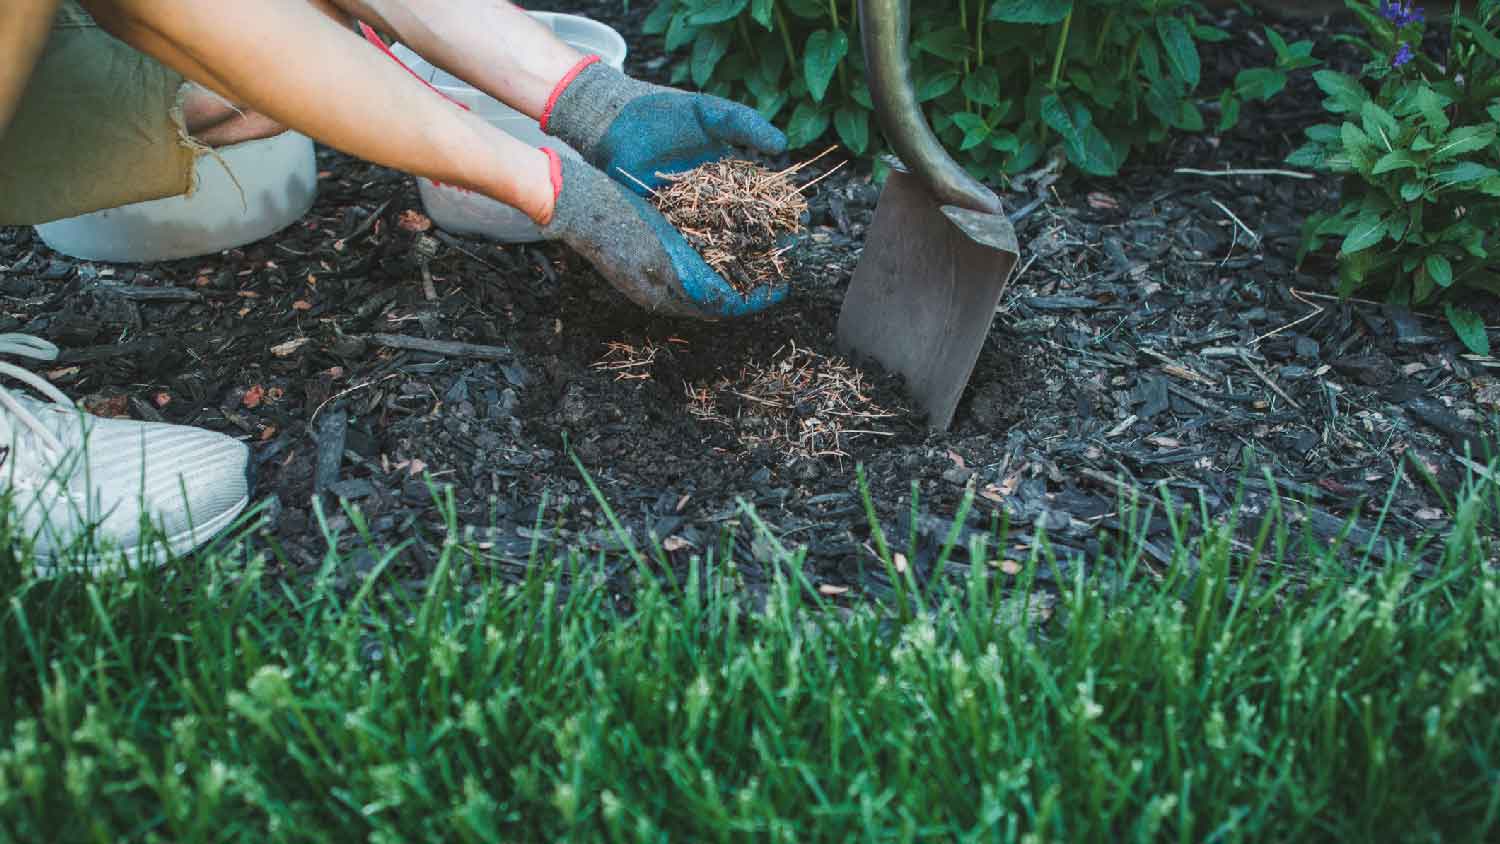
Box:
79 0 552 223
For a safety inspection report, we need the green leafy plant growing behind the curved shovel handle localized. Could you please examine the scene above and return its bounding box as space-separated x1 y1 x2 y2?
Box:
645 0 1272 177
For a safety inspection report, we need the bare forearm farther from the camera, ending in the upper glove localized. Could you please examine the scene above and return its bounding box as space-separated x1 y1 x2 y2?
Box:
329 0 584 118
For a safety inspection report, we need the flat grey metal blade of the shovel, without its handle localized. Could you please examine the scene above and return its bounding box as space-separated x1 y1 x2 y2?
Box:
839 168 1019 430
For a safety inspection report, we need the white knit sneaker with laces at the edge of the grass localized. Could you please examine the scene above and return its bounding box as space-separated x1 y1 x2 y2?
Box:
0 334 251 573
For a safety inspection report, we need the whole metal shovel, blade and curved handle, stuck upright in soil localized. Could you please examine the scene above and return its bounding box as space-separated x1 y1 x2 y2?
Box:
839 0 1019 430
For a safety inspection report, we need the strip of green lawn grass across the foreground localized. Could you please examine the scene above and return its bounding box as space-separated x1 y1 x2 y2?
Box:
0 467 1500 843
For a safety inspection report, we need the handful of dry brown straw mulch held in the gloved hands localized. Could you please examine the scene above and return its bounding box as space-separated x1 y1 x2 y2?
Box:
639 147 839 294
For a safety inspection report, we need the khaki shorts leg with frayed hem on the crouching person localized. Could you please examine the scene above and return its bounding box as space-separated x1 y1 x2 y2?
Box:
0 0 201 225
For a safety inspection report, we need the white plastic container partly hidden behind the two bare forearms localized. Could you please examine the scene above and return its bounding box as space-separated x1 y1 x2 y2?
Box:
392 12 626 243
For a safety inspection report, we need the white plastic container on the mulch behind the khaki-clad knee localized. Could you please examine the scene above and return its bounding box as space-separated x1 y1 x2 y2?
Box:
36 132 318 261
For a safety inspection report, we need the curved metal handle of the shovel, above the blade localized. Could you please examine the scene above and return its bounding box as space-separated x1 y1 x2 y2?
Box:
860 0 1001 214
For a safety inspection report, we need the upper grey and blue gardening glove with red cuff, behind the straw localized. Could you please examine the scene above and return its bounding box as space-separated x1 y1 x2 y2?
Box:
540 55 786 193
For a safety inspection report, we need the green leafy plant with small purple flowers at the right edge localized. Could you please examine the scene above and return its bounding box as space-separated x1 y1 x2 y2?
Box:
1287 0 1500 354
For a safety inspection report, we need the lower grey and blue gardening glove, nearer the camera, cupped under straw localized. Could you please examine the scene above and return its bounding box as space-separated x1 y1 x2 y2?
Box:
542 147 786 319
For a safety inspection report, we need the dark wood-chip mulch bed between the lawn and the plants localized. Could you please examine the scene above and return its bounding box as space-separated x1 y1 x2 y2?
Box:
0 3 1500 591
